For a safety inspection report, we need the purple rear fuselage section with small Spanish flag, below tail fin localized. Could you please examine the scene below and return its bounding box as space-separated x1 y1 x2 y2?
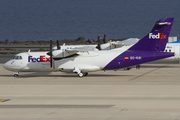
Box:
103 50 174 70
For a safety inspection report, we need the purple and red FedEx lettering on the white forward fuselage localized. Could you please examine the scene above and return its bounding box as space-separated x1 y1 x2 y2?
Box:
28 55 50 62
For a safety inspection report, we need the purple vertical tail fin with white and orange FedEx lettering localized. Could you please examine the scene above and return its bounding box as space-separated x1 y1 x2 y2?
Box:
129 18 174 51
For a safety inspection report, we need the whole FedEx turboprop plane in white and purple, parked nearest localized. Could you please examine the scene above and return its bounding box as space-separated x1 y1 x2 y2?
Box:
3 18 174 77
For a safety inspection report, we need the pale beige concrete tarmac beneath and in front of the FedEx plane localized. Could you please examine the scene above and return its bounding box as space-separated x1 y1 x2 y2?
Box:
0 64 180 120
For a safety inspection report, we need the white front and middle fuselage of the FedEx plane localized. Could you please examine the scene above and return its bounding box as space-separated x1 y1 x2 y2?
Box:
4 50 122 72
